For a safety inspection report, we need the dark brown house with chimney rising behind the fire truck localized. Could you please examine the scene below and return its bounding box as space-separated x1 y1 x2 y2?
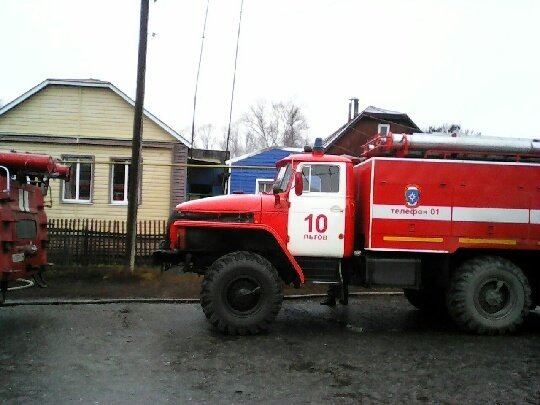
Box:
324 98 422 156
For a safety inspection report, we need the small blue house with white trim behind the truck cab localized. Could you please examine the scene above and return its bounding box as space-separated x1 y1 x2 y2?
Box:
227 146 303 194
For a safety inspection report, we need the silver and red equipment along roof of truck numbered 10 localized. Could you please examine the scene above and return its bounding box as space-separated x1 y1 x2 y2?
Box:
361 133 540 163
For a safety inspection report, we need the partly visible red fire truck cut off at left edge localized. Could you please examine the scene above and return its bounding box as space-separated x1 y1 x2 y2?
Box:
0 151 70 303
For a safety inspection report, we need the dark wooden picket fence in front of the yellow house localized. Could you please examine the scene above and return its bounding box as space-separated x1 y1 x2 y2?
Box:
48 219 166 266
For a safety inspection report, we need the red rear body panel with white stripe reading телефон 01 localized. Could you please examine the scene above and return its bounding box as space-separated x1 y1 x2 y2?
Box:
355 158 540 253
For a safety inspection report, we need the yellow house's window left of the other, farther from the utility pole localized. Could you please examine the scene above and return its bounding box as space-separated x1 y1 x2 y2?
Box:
62 156 94 203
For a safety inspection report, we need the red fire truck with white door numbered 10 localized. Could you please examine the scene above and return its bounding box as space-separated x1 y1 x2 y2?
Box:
154 134 540 334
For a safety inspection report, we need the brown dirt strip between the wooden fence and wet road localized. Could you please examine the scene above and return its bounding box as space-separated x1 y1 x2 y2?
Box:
7 267 357 300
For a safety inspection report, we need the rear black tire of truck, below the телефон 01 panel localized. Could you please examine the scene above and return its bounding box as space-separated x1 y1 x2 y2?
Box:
446 256 531 335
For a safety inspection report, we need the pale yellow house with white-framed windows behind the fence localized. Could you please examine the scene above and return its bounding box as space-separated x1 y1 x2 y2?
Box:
0 79 189 220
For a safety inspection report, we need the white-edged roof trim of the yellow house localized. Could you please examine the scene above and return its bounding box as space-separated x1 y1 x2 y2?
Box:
0 79 191 147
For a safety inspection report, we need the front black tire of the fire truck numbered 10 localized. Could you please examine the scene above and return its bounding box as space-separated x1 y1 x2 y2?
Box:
201 252 283 335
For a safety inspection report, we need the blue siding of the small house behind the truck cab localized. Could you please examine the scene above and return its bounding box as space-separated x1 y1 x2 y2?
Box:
229 148 295 194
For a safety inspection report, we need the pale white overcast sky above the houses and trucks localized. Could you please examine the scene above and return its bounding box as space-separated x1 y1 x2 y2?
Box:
0 0 540 144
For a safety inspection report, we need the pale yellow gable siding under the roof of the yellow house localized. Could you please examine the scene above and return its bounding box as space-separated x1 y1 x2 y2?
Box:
0 85 172 142
